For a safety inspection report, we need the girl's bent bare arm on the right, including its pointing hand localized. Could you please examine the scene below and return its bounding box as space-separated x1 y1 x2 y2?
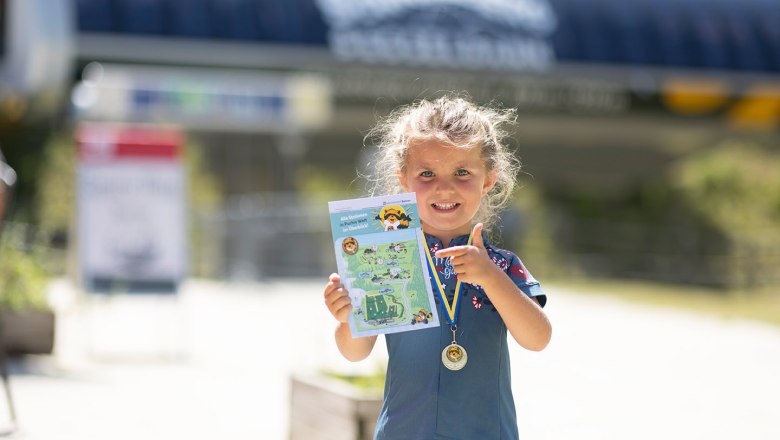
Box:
436 223 552 351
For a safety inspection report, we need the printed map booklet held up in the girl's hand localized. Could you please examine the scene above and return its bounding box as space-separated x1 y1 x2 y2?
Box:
328 193 439 338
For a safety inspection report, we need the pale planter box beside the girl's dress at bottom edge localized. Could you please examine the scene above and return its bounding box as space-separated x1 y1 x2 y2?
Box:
290 376 382 440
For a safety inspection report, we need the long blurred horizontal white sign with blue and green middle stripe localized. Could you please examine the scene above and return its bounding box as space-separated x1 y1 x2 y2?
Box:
72 63 333 133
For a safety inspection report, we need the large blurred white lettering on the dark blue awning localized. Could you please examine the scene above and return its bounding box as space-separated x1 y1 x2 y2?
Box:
318 0 557 71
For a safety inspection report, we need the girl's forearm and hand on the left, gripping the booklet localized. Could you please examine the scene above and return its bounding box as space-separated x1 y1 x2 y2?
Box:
325 273 376 362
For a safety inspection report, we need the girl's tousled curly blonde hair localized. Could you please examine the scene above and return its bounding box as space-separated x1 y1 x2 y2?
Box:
364 95 520 234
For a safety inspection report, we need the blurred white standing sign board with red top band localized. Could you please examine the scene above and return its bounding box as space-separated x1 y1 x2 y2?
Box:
77 124 187 291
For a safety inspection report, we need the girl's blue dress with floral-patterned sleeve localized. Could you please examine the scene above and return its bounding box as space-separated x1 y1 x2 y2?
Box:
374 235 546 440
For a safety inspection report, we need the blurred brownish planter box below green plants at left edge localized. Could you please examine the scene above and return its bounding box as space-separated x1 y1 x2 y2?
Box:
0 309 55 354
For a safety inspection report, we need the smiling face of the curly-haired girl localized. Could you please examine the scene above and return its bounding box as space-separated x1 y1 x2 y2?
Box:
398 140 496 246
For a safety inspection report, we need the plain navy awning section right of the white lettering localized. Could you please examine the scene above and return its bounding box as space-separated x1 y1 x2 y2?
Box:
550 0 780 72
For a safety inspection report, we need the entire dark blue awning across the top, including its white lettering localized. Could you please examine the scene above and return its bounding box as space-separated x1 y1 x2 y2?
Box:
77 0 780 73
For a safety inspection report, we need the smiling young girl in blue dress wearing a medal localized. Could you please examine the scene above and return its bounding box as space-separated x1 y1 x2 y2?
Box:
324 97 551 440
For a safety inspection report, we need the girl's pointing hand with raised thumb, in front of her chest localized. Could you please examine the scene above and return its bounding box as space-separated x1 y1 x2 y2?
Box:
436 223 501 285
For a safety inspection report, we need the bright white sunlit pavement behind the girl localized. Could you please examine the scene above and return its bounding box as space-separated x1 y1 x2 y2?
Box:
0 280 780 440
